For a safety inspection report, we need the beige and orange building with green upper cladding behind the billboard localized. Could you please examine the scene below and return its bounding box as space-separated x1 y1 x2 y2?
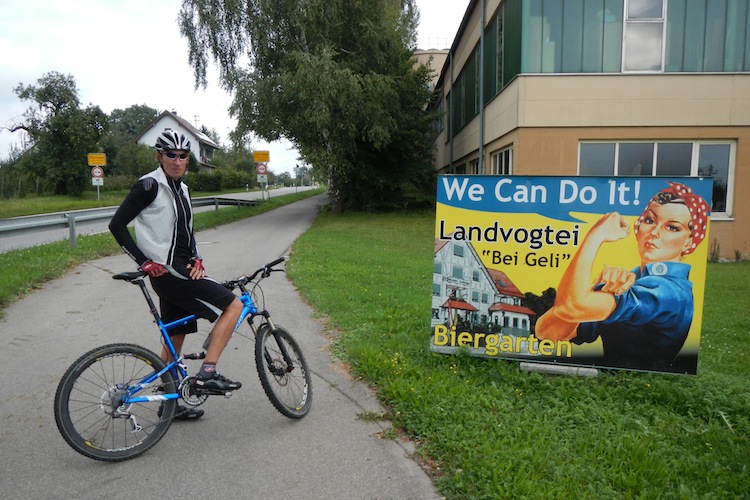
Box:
433 0 750 260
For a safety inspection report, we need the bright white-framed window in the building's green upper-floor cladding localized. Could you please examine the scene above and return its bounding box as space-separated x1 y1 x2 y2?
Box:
622 0 666 71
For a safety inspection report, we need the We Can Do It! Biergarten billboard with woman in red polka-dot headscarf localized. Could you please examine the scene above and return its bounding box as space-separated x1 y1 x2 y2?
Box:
430 175 712 374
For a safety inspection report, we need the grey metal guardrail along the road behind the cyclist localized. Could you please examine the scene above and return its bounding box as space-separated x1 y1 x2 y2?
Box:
0 196 258 248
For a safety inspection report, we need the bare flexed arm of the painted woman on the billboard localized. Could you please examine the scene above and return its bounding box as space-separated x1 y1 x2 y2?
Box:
536 212 634 340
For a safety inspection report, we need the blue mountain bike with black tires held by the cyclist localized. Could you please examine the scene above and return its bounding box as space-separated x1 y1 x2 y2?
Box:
55 257 312 462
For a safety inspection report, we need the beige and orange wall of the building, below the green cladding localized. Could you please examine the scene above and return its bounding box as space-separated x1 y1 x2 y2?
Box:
435 74 750 260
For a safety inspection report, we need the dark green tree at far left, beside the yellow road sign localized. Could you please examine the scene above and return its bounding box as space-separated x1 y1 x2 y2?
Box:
11 71 108 195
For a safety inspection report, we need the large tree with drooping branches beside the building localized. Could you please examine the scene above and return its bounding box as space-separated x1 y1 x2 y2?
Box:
180 0 430 212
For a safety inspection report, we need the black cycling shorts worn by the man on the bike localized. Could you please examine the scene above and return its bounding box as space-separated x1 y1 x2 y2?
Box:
151 274 237 336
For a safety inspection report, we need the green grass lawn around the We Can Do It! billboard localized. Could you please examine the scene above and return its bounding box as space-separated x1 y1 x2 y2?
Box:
288 213 750 499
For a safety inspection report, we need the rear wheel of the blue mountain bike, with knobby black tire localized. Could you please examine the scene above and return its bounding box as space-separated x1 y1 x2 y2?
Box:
55 344 177 462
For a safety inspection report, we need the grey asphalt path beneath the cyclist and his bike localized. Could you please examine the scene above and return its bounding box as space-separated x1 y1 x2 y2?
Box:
0 196 440 499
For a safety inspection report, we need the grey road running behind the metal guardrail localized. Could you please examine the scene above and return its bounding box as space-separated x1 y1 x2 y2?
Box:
0 186 313 253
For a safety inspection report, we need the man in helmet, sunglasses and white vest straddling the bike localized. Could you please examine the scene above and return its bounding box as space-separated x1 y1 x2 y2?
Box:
109 129 242 420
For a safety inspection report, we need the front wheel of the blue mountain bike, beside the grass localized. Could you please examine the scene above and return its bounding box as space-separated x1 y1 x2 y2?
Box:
255 325 312 419
